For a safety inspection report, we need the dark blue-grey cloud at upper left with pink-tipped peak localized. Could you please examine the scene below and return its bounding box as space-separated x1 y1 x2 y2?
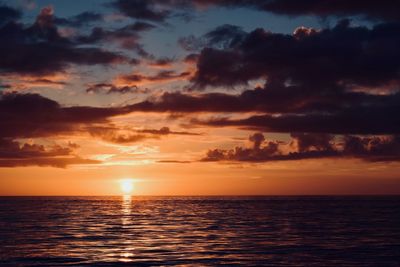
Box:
0 7 128 75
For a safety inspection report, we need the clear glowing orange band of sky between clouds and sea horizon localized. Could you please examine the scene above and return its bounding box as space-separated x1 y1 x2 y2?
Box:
0 159 400 196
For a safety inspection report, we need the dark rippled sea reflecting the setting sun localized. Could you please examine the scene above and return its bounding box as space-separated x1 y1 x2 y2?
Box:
0 197 400 266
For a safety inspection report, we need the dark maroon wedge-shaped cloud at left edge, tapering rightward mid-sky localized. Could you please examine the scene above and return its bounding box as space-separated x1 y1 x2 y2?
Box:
0 93 128 139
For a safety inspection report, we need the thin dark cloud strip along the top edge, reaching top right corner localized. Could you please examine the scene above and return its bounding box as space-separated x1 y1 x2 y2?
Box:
111 0 400 22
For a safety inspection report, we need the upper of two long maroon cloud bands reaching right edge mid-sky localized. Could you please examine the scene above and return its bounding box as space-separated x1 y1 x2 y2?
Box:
131 86 400 114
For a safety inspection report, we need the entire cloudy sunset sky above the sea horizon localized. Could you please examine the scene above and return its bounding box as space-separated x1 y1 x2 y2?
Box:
0 0 400 195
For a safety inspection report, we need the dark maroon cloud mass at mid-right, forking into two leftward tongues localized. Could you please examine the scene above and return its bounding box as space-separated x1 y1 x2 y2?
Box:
129 86 400 134
